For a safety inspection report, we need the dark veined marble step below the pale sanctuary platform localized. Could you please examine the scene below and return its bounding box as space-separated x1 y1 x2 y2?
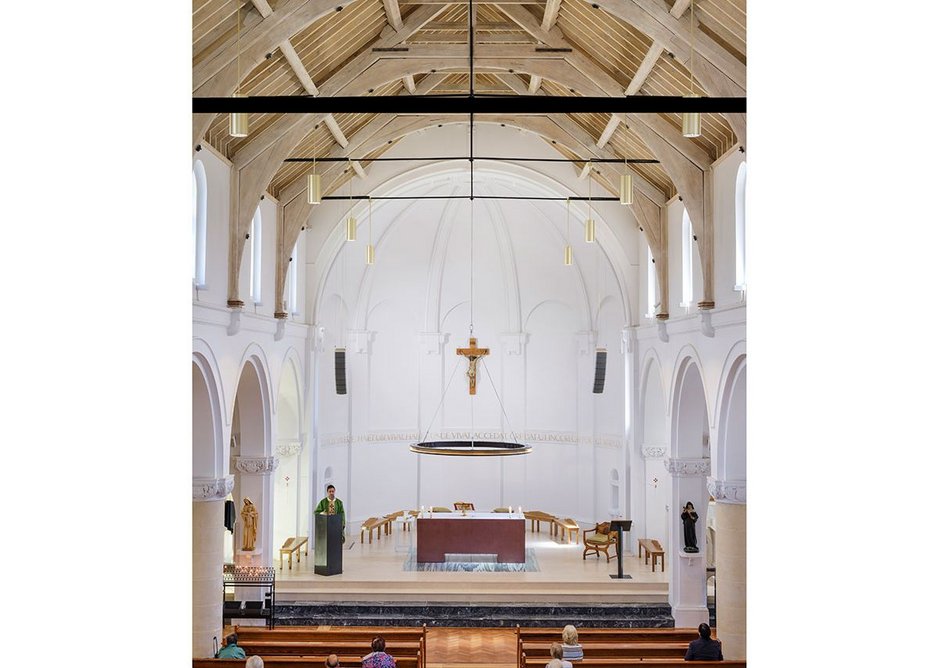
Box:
276 601 674 628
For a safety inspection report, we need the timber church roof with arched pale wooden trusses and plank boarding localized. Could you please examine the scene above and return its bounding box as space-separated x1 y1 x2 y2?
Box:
192 0 746 318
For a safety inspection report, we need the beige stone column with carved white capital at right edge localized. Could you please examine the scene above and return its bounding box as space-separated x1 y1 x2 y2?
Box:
708 480 746 660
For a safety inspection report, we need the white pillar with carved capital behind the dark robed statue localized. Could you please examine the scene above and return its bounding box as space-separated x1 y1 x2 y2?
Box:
666 459 708 628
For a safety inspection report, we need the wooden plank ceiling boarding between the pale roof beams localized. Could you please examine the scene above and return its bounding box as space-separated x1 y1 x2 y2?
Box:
192 0 746 198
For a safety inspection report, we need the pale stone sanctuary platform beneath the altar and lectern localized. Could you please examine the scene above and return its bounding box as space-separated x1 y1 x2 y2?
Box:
276 523 670 605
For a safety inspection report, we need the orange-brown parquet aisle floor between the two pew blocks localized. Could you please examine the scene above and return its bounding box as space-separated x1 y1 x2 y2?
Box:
427 628 518 668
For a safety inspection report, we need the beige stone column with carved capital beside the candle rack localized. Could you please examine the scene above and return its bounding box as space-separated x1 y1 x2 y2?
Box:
192 476 234 659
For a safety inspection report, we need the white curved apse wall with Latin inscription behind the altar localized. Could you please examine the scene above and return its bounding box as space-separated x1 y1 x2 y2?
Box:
311 121 639 522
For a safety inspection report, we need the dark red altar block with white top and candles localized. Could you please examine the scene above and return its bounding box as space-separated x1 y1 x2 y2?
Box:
417 512 525 564
